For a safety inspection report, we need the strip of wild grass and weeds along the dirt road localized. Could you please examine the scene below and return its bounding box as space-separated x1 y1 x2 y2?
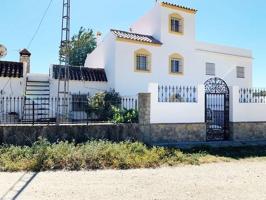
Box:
0 140 266 172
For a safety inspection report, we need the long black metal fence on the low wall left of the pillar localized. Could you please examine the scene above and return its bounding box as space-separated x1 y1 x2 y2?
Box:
0 96 138 124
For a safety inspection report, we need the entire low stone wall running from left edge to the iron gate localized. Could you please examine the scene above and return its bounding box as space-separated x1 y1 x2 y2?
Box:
0 124 206 145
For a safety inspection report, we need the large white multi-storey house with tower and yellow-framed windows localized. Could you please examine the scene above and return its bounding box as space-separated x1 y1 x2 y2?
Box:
85 2 253 95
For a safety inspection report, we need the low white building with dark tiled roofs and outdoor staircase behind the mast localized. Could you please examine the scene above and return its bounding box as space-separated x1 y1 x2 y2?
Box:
0 49 107 124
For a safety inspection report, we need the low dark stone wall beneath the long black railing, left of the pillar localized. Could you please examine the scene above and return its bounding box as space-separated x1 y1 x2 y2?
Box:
0 124 148 145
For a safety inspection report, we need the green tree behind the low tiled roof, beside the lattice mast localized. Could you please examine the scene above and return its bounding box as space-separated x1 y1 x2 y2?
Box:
62 27 97 66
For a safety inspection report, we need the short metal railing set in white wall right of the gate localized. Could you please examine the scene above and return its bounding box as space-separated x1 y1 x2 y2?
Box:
239 88 266 103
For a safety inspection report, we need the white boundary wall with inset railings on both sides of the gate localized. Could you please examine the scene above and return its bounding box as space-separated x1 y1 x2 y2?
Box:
148 83 266 123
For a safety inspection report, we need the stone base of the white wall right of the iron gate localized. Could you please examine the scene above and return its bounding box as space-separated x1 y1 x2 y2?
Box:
230 122 266 141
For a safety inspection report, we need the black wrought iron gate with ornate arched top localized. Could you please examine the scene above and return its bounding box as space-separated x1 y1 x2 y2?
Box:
205 78 229 141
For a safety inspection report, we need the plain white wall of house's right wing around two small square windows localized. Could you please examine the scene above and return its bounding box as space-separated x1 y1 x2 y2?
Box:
195 42 253 87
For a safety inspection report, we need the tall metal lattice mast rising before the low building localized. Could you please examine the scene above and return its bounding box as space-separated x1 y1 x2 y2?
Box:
57 0 70 120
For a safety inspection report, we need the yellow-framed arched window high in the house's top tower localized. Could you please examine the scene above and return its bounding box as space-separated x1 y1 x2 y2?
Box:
169 13 184 35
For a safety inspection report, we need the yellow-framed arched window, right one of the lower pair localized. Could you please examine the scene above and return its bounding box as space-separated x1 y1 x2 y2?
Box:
169 53 184 75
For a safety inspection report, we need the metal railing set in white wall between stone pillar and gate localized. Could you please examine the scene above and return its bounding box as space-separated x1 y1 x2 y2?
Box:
158 86 198 103
